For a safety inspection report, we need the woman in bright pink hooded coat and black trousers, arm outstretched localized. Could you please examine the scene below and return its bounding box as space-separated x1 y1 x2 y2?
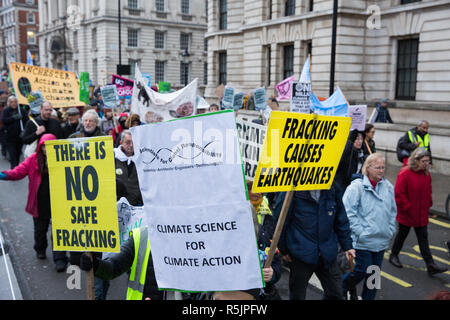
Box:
0 134 68 272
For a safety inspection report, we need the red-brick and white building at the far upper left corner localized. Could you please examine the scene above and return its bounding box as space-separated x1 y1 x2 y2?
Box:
0 0 39 70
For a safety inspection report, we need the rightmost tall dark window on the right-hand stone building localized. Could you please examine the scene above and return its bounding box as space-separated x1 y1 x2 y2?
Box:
396 39 419 100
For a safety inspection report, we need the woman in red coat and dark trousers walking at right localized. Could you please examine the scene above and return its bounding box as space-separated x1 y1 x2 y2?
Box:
389 148 447 276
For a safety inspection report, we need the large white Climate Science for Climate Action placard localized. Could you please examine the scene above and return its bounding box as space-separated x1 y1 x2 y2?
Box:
131 110 263 291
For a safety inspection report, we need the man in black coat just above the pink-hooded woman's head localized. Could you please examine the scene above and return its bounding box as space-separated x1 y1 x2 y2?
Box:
22 101 64 144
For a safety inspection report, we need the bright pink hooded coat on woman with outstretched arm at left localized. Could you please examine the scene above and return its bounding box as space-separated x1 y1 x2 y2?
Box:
4 134 56 218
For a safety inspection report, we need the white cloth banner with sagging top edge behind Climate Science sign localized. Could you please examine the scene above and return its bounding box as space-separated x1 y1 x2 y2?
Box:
131 66 198 123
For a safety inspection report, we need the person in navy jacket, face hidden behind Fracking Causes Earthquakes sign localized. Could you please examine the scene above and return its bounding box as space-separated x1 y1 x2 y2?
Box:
274 183 355 300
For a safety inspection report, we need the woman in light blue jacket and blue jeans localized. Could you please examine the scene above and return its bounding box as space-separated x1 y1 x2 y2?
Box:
342 153 397 300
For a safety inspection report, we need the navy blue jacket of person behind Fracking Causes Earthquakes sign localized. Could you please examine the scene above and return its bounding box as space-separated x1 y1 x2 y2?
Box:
274 185 352 267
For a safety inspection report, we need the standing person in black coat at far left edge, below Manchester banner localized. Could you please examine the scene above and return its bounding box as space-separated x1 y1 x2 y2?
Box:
2 96 27 169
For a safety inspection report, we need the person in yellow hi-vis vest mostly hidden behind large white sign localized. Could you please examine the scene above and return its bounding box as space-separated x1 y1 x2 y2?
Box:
80 228 165 300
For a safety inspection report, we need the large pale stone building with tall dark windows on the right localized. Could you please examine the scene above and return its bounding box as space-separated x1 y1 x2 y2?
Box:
206 0 450 104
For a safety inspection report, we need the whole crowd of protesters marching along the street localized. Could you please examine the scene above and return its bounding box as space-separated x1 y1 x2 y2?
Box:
0 92 446 300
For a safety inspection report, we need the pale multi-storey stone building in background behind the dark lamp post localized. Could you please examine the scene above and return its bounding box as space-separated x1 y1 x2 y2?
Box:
39 0 207 87
